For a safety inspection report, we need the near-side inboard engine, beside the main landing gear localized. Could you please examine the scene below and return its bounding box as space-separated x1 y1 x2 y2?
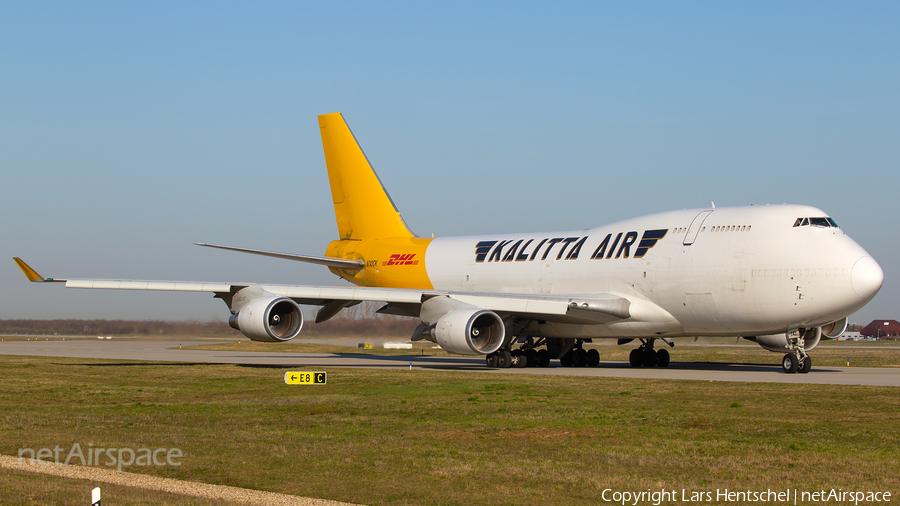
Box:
432 309 506 355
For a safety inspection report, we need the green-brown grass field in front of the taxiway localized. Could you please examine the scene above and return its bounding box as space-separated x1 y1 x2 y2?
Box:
0 356 900 505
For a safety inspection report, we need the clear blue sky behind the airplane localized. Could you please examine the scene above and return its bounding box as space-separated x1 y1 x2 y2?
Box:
0 2 900 323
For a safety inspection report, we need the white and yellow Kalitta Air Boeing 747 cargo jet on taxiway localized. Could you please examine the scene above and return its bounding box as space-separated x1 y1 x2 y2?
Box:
15 113 884 373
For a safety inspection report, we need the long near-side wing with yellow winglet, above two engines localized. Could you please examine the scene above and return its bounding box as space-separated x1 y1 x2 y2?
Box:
15 258 631 324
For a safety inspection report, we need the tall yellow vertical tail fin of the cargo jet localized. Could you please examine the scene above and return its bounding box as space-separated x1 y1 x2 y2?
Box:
319 112 415 240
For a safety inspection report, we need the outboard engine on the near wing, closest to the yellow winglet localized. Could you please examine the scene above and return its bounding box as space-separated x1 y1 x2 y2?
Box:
228 297 303 343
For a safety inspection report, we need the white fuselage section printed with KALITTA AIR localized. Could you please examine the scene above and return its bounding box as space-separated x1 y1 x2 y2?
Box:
425 205 883 338
